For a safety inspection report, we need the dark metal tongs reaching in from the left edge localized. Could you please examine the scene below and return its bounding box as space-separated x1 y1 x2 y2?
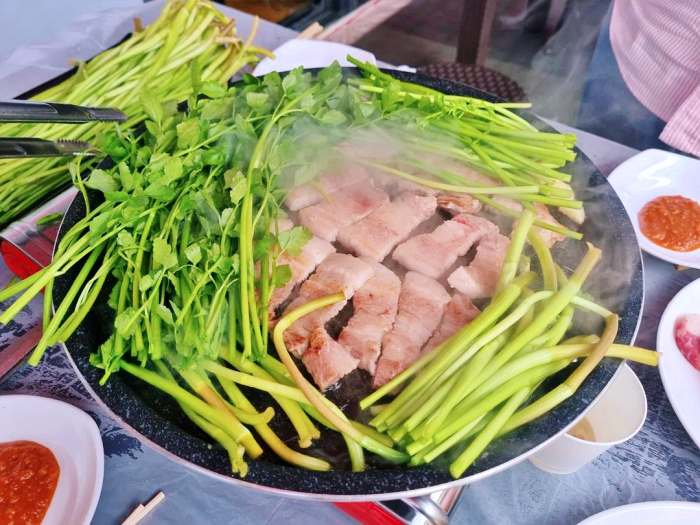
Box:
0 100 127 159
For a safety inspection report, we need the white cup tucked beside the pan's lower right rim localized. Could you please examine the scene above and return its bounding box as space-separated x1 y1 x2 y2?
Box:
529 363 647 474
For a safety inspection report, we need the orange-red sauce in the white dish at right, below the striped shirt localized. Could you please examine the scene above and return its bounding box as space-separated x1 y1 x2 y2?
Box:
639 195 700 252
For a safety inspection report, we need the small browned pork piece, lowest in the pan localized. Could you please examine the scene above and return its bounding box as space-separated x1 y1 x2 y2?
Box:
301 326 359 390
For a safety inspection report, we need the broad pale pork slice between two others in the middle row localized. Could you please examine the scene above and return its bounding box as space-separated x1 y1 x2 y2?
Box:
338 193 437 262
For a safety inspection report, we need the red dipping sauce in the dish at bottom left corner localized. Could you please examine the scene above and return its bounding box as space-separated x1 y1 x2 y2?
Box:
0 441 60 525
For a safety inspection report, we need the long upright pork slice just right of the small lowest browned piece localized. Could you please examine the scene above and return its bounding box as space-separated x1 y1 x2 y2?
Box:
338 261 401 374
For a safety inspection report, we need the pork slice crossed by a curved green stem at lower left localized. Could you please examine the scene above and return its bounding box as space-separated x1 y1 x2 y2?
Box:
284 253 374 357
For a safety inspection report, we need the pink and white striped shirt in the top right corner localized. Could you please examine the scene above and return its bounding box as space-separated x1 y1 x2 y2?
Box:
610 0 700 156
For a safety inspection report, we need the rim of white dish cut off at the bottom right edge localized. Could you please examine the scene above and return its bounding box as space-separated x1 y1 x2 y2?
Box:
578 501 700 525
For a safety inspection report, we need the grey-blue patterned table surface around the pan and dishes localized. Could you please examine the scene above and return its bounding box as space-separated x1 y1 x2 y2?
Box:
0 2 700 525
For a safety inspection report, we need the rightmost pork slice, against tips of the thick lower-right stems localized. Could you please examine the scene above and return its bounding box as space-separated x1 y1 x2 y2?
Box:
447 233 510 299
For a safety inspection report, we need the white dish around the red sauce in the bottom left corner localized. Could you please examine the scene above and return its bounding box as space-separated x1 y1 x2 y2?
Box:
0 395 104 525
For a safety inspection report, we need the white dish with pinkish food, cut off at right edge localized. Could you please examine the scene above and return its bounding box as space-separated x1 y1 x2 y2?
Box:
656 279 700 446
